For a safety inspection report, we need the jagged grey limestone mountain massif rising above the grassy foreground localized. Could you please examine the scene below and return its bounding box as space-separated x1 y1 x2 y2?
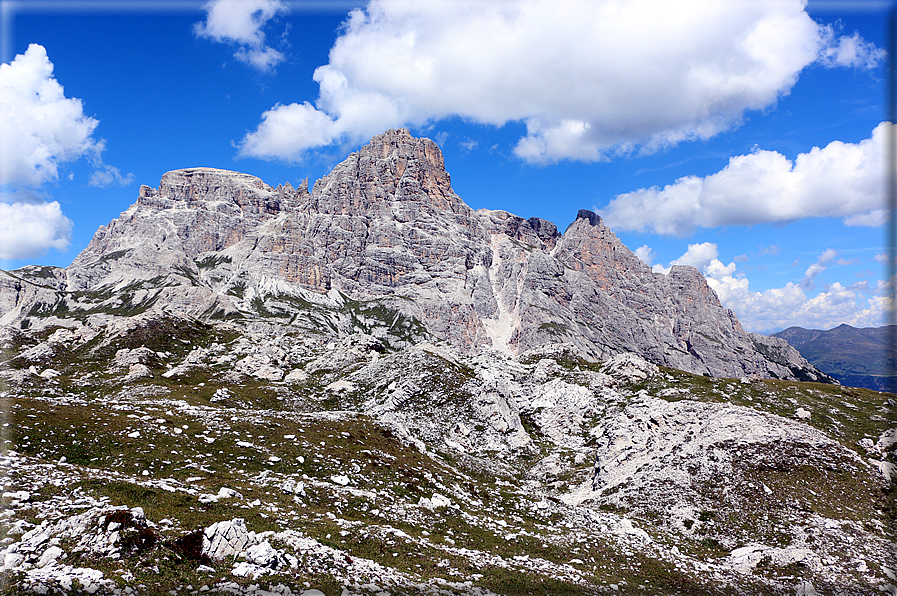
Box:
0 130 822 378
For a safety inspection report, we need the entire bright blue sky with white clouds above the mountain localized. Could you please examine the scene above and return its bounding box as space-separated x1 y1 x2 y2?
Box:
0 0 893 331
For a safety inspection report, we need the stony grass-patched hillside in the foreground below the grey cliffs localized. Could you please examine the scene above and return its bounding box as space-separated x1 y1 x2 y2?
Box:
0 312 897 596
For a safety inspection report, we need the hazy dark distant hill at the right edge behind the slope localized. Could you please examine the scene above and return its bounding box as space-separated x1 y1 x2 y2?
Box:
772 325 897 391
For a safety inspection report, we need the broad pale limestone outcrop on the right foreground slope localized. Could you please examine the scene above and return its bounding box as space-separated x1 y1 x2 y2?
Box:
576 398 865 525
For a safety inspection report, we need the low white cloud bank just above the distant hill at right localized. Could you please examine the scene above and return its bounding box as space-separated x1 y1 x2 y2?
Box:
642 242 889 332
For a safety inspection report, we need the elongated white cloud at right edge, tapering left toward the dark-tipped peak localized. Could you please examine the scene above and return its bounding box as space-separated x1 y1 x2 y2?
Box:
598 122 894 236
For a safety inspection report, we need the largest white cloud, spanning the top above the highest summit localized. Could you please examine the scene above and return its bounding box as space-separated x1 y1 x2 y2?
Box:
233 0 882 162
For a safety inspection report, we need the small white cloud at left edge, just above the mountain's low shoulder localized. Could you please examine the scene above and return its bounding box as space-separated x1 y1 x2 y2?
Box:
0 201 72 259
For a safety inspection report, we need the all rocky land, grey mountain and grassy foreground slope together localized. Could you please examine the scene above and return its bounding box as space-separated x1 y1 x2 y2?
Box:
0 131 897 596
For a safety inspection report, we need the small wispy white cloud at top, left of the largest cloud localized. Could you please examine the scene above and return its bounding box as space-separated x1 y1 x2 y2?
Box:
193 0 289 72
